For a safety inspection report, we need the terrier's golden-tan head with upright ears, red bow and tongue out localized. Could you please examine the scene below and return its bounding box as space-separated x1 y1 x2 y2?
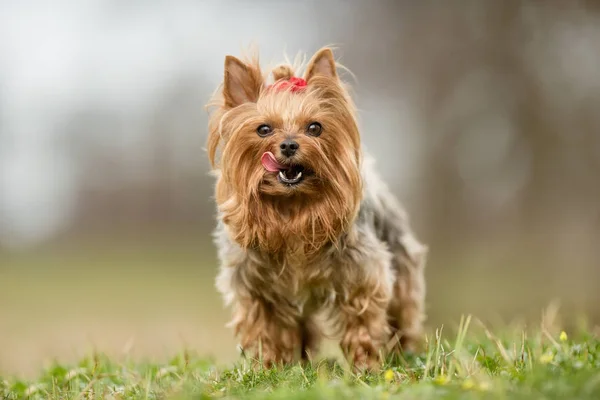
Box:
208 49 361 252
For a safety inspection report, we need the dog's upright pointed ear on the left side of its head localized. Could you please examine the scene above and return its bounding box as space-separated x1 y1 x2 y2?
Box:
223 56 263 107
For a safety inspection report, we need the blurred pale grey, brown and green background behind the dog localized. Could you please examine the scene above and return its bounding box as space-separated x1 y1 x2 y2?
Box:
0 0 600 374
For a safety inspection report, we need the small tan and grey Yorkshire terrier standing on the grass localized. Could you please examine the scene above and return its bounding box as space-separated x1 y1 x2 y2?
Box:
207 48 427 368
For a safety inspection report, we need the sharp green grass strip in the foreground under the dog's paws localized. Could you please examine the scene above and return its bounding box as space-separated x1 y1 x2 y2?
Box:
0 318 600 399
